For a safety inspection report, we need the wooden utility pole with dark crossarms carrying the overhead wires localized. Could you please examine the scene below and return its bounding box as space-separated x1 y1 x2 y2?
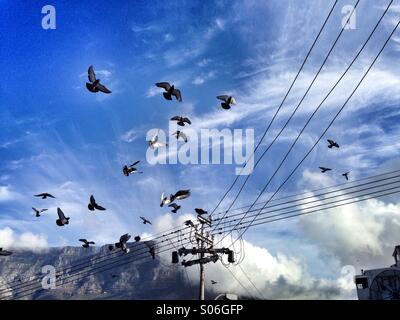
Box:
172 215 235 300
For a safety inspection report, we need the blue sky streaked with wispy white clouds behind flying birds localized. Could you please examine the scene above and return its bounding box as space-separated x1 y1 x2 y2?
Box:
0 0 400 300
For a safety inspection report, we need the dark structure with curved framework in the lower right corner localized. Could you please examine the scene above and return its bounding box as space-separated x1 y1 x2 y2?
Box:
354 245 400 300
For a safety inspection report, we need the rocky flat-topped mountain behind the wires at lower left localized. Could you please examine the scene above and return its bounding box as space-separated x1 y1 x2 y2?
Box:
0 243 216 300
